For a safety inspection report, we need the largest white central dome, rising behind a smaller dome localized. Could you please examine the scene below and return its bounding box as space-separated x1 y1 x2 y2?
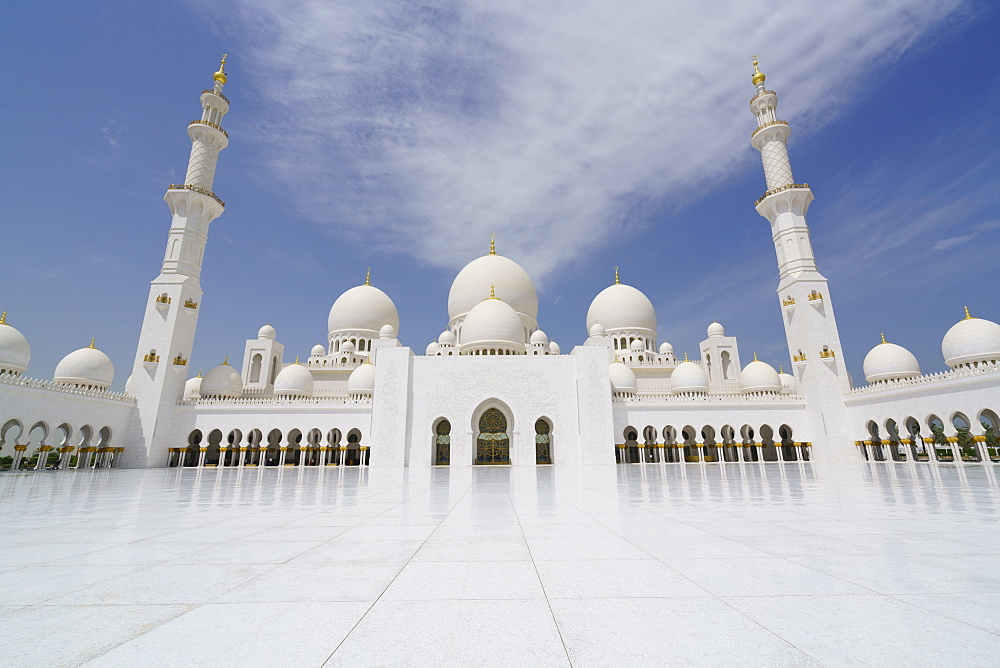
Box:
448 255 538 324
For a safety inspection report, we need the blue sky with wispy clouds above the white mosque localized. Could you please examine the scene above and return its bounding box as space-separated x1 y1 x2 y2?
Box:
0 0 1000 388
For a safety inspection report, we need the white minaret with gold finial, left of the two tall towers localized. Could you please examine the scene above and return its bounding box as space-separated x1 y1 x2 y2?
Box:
123 56 229 466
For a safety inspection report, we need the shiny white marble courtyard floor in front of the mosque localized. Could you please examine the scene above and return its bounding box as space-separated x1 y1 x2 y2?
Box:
0 463 1000 666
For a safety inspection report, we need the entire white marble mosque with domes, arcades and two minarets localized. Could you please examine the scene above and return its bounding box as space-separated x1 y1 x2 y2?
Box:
0 58 1000 469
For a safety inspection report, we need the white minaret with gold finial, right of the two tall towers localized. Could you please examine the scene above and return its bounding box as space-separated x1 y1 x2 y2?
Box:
750 56 856 457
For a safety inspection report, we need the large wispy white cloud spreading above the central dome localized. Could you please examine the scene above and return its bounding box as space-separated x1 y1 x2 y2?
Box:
208 0 962 278
